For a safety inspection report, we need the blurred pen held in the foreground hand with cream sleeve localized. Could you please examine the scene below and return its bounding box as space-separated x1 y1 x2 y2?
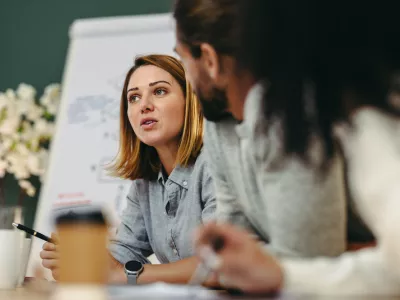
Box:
188 237 224 285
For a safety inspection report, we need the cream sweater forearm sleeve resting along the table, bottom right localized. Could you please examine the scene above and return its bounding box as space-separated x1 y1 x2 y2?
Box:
282 247 400 295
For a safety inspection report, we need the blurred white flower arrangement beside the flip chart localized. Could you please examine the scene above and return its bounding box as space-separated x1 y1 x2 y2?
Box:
0 83 60 201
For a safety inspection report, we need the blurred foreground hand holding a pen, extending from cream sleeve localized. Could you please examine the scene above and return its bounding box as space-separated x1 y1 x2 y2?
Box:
195 223 283 293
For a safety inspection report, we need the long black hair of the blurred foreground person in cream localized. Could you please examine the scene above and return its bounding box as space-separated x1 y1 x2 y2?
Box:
236 0 400 168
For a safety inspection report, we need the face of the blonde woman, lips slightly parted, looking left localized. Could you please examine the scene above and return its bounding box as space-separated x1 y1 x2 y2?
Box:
127 65 185 148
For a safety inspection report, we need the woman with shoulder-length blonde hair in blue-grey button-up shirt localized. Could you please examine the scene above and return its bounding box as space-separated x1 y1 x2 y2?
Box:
41 55 215 284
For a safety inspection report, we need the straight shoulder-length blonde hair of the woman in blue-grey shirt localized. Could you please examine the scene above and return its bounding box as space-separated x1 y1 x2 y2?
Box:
110 54 203 180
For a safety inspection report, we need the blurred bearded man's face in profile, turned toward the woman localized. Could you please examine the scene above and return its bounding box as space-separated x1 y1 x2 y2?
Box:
175 41 231 122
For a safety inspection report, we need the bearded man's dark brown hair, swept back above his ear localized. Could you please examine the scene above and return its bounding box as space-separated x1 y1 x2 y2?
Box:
173 0 238 58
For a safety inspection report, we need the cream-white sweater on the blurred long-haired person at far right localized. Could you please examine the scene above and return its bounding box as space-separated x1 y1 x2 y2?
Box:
282 109 400 296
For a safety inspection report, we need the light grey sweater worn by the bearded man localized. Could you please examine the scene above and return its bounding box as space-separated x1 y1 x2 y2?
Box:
204 84 370 257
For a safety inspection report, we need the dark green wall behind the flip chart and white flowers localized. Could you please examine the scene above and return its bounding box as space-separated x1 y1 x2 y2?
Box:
0 0 173 226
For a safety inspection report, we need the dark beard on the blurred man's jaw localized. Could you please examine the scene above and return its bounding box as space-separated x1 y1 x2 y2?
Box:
196 87 231 122
